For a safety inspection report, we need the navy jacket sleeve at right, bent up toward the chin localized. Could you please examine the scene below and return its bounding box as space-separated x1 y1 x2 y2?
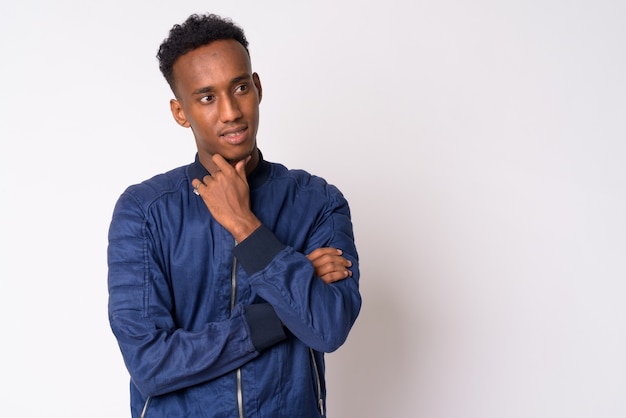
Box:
234 185 361 352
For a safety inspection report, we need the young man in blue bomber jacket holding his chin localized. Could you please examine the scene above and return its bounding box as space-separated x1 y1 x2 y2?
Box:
108 15 361 418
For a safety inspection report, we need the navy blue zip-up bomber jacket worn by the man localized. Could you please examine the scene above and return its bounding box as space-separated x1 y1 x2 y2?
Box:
108 156 361 418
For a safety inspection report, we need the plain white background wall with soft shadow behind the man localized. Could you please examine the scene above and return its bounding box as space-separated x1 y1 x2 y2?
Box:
0 0 626 418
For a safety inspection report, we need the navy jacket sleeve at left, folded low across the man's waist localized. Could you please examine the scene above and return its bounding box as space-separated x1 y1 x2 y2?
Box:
108 193 286 396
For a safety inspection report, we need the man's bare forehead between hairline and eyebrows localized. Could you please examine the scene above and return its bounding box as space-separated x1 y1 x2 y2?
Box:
173 39 252 93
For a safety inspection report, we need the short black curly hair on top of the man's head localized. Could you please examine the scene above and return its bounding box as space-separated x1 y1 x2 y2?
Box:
157 14 250 91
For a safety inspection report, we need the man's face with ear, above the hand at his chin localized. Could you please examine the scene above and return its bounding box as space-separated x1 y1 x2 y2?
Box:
170 39 262 172
